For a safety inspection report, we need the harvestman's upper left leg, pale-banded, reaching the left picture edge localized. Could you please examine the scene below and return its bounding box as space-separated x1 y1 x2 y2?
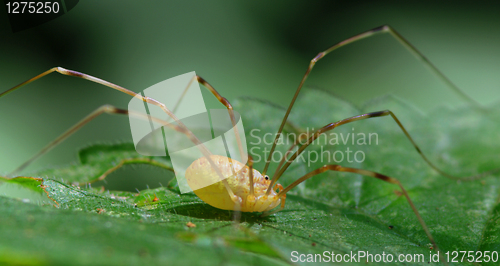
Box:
0 67 235 197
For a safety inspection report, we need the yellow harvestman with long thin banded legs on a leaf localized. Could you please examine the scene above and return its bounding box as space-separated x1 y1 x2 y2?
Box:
0 25 498 256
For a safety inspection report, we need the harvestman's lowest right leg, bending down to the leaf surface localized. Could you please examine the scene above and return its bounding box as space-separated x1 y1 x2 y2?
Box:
278 164 439 260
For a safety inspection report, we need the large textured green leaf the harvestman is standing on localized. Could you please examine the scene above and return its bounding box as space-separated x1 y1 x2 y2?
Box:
0 89 500 265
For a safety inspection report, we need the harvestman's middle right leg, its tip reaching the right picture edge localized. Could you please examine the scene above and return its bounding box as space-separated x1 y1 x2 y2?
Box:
267 110 500 193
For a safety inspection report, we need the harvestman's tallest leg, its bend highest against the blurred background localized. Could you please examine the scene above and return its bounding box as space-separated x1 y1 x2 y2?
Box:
262 25 482 174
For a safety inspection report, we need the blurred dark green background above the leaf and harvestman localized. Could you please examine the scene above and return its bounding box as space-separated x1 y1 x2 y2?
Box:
0 0 500 190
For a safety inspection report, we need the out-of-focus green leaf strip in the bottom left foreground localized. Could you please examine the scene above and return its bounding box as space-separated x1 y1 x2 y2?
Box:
0 197 288 265
